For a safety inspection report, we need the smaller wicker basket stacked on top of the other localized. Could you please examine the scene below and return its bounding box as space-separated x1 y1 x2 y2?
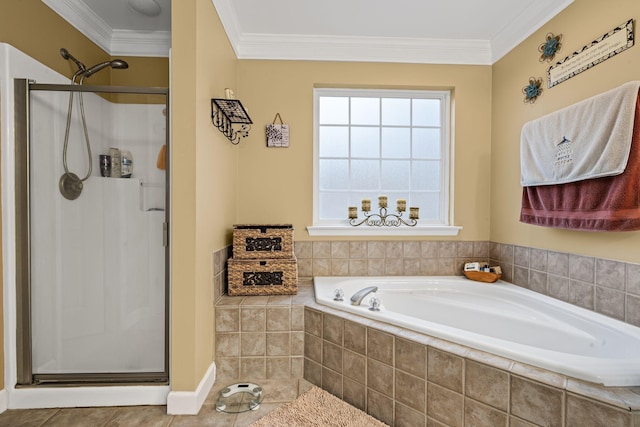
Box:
233 224 294 259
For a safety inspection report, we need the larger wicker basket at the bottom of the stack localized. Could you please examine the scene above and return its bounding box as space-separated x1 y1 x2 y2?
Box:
227 258 298 295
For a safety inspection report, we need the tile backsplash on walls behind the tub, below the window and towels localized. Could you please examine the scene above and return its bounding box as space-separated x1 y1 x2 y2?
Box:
295 240 640 326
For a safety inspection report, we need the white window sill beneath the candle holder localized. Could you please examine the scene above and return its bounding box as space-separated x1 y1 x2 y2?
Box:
307 225 462 236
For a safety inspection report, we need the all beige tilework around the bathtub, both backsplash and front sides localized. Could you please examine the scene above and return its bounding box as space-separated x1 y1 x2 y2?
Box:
213 241 640 427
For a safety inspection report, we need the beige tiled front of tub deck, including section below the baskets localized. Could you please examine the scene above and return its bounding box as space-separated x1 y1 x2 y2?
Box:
216 283 640 427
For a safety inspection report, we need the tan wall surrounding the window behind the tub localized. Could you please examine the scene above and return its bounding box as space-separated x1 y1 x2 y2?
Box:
237 60 491 240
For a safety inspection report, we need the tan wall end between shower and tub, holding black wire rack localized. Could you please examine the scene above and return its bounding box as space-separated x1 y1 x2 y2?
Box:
171 0 238 391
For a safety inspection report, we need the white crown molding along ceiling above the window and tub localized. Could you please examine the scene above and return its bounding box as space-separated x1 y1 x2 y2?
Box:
212 0 574 65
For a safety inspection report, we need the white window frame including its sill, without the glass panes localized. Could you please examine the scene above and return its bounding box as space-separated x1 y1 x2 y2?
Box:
307 88 462 236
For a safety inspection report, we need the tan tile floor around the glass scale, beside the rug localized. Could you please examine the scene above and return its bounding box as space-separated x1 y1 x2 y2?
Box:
0 378 312 427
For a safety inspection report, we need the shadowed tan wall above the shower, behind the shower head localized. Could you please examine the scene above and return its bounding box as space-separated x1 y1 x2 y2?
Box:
0 0 169 87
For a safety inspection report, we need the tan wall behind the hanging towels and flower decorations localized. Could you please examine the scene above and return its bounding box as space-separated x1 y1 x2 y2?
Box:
491 0 640 262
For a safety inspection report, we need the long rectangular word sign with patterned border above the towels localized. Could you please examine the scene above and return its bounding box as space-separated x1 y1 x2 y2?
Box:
548 19 634 88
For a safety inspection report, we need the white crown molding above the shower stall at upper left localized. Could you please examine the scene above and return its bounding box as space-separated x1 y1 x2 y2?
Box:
42 0 171 57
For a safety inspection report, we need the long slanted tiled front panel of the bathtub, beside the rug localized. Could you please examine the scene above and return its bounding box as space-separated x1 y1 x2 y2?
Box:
304 303 640 427
